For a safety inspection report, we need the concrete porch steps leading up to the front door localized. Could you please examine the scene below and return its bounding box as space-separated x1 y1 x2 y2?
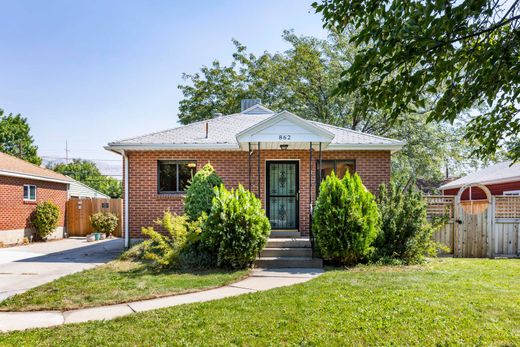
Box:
255 234 323 268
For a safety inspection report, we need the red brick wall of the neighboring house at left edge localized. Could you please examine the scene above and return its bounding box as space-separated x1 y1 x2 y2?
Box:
0 176 67 230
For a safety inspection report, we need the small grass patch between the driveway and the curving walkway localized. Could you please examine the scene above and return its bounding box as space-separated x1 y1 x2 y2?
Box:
0 260 248 311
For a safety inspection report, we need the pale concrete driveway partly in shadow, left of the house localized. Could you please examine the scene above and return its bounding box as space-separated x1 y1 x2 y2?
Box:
0 237 123 301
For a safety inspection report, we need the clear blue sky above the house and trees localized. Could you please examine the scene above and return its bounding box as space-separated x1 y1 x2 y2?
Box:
0 0 326 168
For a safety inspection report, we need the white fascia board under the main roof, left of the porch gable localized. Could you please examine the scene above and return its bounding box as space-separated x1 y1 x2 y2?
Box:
105 143 240 154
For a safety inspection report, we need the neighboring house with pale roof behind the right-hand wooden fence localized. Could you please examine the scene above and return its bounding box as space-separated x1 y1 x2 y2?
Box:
439 161 520 200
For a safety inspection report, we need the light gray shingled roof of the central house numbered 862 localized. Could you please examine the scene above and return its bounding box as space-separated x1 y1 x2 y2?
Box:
109 108 403 147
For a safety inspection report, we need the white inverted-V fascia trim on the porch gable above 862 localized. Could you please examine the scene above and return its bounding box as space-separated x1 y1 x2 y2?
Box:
236 111 334 143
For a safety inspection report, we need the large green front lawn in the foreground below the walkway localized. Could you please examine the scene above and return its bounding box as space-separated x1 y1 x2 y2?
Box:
0 259 520 346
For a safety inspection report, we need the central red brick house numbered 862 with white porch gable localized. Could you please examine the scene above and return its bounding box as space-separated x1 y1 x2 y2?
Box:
106 100 403 247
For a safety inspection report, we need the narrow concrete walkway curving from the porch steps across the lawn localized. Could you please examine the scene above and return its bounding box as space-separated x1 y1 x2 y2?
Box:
0 269 323 332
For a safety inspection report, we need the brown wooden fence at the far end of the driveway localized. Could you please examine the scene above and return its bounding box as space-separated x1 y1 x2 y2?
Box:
65 198 123 237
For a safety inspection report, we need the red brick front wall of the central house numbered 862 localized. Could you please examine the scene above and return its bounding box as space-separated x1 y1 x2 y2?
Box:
127 150 390 237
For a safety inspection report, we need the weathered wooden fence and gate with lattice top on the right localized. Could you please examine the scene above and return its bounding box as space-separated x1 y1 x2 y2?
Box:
426 196 520 258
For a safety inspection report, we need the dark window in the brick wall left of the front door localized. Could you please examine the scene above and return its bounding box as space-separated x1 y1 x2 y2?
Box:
157 160 197 194
